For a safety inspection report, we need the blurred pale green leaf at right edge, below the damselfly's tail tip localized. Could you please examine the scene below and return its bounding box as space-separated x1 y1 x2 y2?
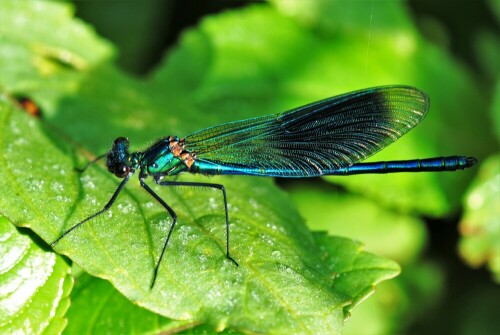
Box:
459 155 500 283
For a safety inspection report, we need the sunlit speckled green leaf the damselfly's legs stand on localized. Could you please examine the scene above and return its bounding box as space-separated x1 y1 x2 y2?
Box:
0 100 345 333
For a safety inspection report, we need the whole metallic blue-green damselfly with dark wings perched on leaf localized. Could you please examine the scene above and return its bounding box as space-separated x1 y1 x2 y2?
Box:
51 86 477 287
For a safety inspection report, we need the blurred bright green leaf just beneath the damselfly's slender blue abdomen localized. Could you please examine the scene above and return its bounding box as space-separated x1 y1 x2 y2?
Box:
288 185 427 264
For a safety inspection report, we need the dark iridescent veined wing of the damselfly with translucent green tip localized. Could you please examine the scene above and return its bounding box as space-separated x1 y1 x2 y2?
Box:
185 86 429 177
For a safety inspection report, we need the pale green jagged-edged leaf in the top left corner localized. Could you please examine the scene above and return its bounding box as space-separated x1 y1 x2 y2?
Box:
0 0 113 110
